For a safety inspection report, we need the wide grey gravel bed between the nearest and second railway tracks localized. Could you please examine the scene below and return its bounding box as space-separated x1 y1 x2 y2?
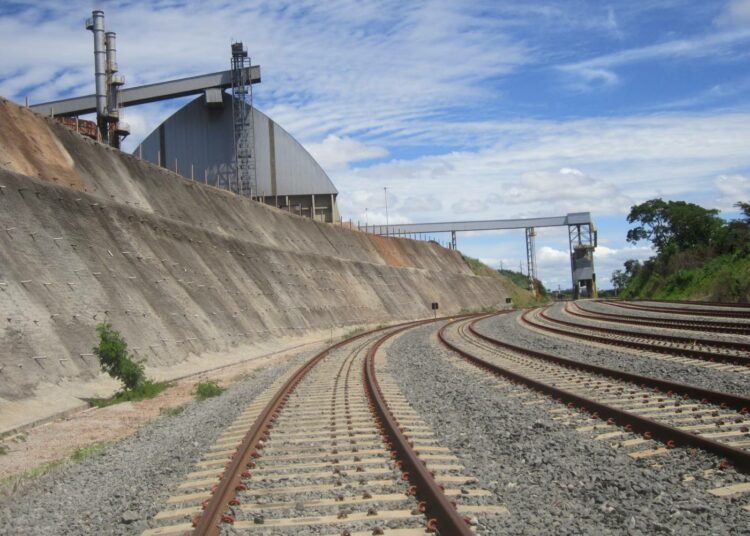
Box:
388 326 750 535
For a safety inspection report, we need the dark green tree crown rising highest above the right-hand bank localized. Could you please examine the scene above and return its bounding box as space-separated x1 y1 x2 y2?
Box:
627 198 723 254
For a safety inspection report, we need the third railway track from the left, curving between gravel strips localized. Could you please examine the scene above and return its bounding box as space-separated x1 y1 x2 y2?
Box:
519 308 750 373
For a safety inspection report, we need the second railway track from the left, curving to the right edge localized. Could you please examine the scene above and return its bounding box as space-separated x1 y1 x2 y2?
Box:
439 319 750 472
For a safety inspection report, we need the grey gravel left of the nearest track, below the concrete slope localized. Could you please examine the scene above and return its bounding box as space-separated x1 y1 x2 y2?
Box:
0 351 315 535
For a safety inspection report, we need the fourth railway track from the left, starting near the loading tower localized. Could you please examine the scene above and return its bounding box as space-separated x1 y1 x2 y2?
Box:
565 301 750 335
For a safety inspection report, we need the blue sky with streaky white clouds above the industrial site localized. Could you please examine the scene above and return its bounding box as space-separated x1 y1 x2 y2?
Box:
0 0 750 288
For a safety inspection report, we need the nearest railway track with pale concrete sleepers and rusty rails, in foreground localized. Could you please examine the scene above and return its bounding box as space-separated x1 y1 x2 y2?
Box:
143 322 507 536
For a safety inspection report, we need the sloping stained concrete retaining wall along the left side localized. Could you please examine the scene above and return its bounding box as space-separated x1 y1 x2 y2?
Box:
0 100 507 429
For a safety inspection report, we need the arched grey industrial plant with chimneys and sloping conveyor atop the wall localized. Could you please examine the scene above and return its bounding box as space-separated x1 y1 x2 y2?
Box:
31 10 340 222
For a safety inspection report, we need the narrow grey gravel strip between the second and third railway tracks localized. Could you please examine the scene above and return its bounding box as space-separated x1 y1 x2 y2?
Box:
476 312 750 396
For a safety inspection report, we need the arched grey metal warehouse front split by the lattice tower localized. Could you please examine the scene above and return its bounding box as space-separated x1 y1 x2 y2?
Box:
135 90 339 222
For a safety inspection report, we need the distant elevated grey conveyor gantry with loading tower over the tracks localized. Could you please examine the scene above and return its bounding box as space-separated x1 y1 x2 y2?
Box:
362 212 597 299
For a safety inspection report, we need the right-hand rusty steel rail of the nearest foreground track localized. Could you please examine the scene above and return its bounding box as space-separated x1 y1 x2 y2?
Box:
362 326 474 536
